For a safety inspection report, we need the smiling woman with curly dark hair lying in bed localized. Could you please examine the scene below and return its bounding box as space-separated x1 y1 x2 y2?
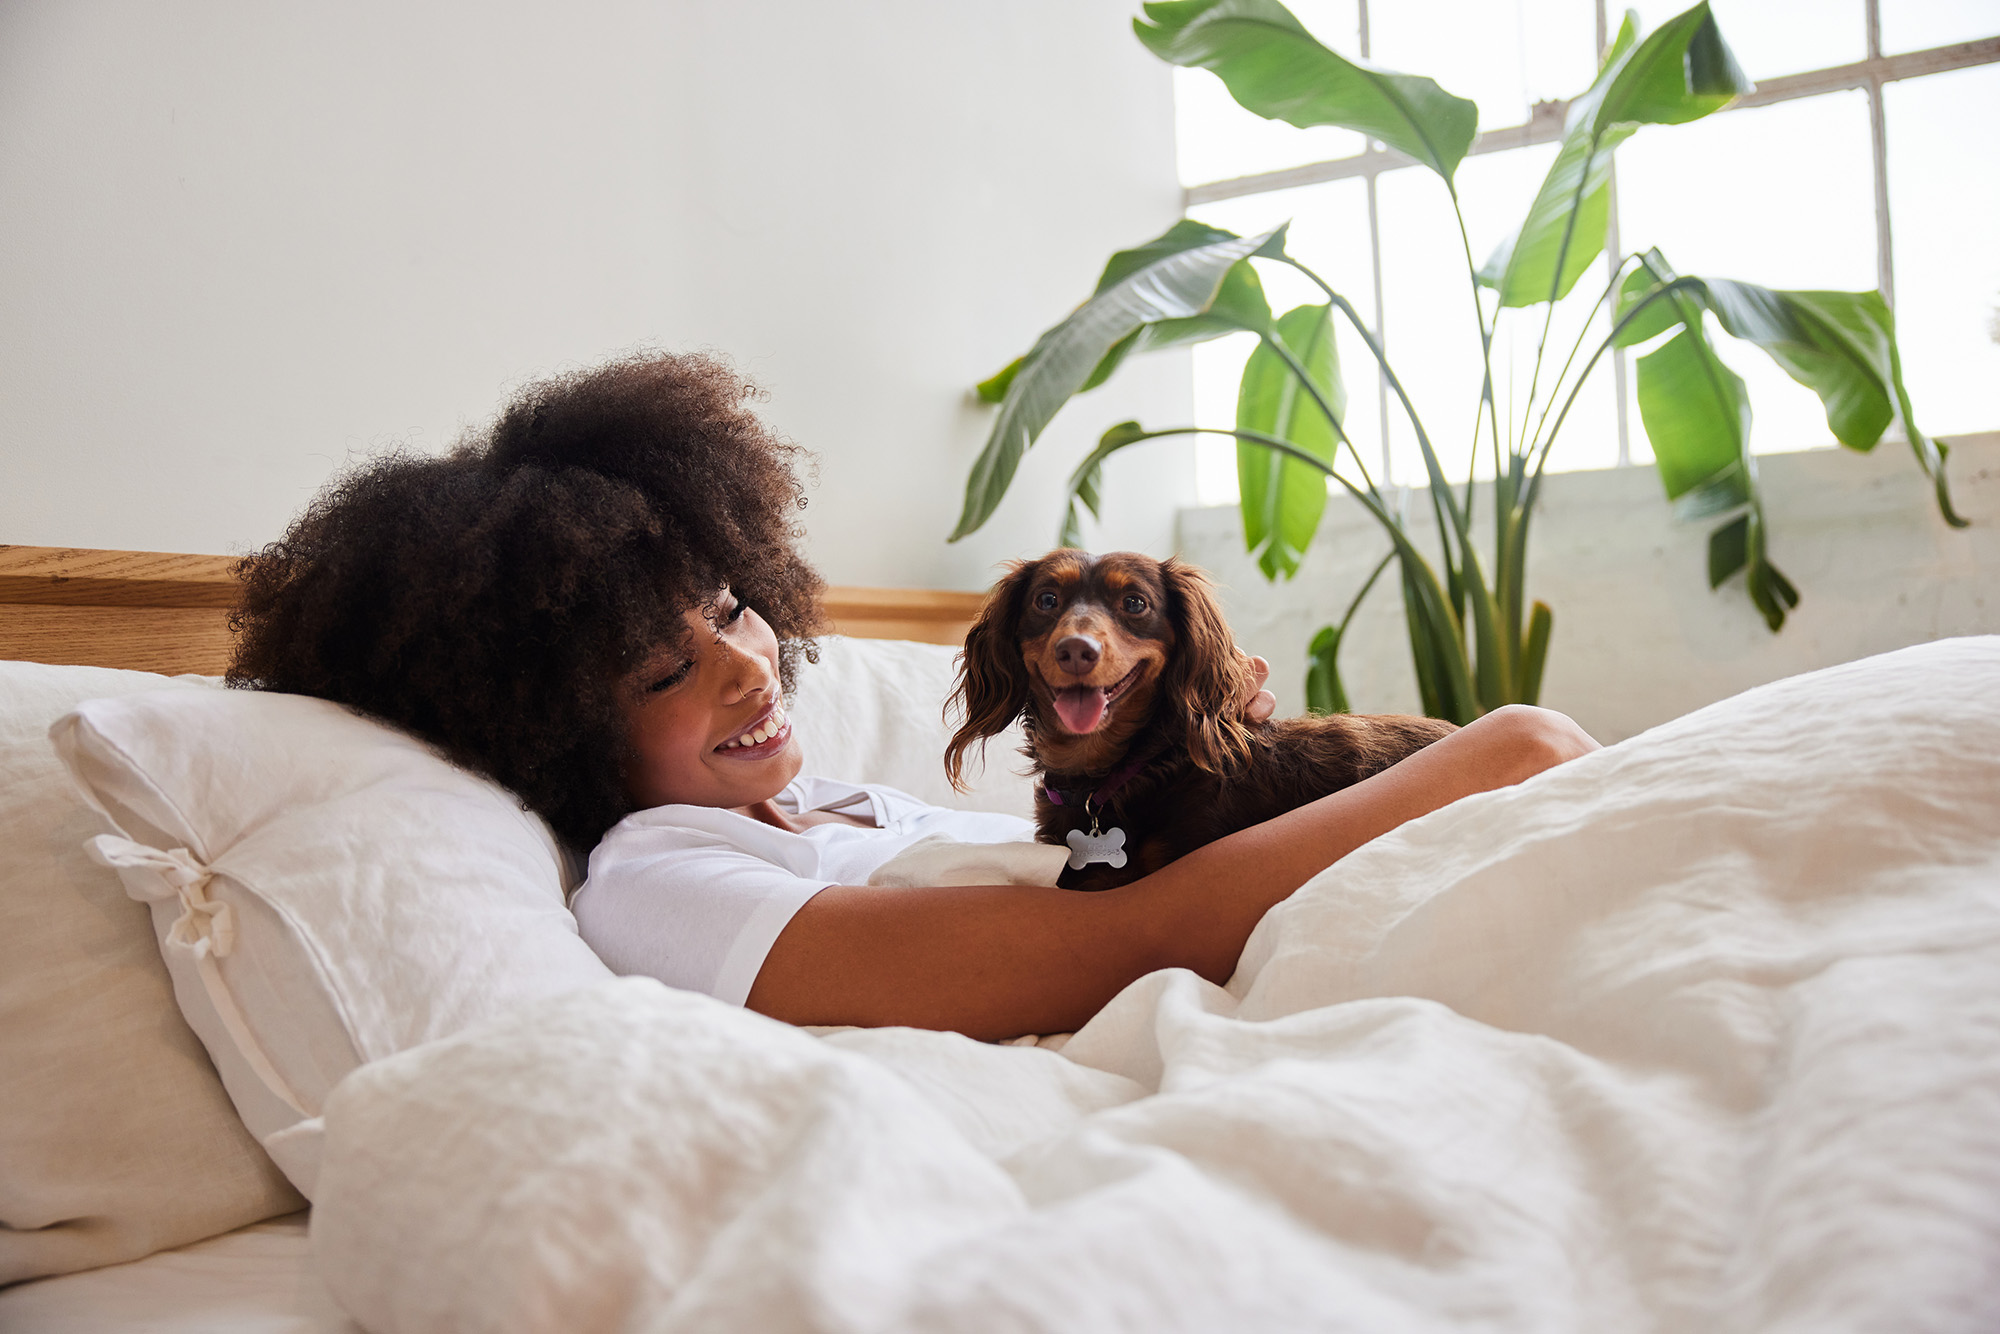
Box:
230 356 1596 1038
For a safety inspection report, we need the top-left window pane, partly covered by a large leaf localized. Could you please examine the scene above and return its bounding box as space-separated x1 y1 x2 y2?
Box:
1174 0 1368 186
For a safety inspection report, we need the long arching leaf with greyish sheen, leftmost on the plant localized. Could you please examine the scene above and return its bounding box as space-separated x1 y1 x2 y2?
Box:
950 228 1284 542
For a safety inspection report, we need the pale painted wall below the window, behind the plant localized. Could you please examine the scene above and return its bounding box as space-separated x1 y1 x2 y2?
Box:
1180 434 2000 740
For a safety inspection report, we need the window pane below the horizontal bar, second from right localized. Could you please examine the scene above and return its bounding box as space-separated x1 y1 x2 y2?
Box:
1618 92 1876 458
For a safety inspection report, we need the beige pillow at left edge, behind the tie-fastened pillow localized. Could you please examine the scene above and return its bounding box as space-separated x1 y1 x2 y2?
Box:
0 662 300 1284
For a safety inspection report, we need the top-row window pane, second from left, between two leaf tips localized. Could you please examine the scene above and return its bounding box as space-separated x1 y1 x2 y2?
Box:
1368 0 1598 130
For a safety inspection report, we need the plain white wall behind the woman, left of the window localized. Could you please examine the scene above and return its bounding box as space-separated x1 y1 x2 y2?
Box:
0 0 1192 588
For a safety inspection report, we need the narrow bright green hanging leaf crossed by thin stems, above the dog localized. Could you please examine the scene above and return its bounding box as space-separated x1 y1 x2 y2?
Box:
1236 306 1346 580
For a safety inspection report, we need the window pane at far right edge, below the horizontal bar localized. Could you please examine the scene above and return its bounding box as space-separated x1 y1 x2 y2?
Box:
1882 66 2000 434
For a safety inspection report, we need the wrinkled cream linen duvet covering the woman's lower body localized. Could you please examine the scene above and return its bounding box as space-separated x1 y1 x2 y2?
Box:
312 638 2000 1334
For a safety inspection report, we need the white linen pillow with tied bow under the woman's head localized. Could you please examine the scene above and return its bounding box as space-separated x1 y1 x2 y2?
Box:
50 690 612 1198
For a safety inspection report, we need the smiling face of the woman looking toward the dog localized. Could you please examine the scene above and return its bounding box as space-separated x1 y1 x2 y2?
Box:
622 588 802 806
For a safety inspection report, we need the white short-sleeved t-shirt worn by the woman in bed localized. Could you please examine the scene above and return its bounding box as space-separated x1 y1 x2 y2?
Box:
570 776 1054 1006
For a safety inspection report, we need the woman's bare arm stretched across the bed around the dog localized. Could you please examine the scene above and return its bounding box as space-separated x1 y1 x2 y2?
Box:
748 706 1596 1038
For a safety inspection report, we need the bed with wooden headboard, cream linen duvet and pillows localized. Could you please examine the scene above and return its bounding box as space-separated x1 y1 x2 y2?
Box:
0 548 2000 1332
